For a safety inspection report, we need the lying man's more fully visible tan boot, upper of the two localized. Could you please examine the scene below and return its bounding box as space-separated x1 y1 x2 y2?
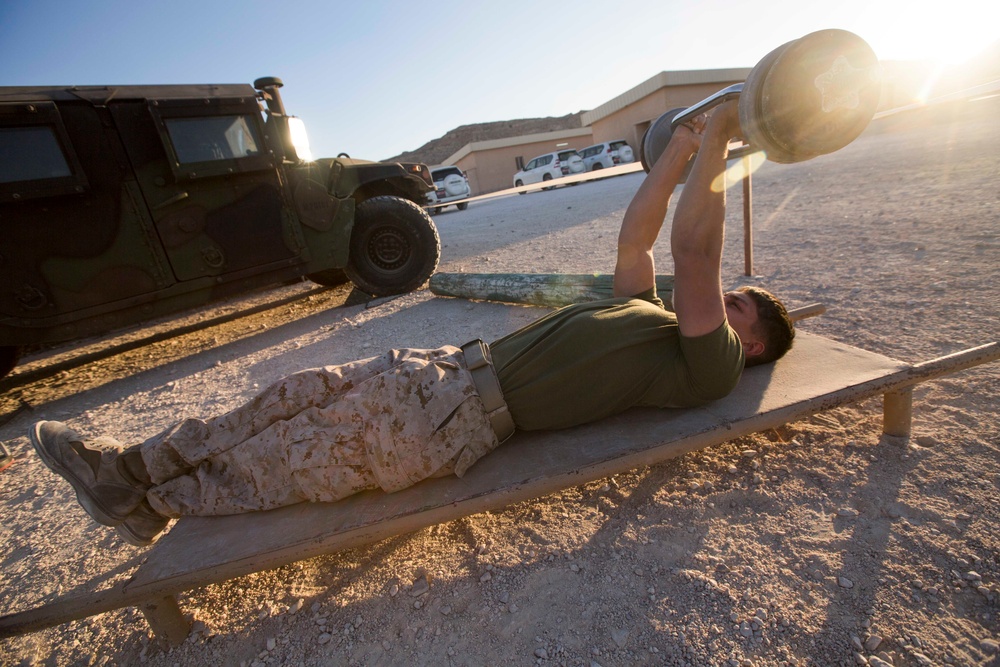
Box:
31 421 151 526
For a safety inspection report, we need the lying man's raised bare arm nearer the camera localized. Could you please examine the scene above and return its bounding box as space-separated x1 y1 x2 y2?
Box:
670 102 740 337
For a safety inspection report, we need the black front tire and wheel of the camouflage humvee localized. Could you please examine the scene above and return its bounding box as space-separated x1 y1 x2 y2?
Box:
344 195 441 296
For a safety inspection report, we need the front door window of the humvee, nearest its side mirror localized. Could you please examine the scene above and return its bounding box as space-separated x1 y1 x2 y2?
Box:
164 116 261 164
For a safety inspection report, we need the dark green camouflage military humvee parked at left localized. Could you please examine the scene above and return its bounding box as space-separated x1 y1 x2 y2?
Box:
0 77 440 376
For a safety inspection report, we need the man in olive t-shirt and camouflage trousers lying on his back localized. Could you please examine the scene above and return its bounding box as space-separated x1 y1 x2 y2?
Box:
31 102 795 546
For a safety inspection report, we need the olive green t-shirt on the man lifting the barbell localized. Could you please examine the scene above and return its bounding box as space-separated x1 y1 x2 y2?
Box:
490 289 744 430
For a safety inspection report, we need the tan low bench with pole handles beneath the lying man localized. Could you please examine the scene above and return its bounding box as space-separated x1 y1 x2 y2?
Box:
0 331 1000 643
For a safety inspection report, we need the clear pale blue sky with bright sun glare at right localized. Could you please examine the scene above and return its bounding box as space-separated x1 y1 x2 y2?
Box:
0 0 1000 159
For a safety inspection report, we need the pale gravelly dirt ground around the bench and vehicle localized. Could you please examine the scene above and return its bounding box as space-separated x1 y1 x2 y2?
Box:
0 98 1000 667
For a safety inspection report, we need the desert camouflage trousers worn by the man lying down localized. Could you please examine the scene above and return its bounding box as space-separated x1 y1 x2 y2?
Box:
139 346 498 517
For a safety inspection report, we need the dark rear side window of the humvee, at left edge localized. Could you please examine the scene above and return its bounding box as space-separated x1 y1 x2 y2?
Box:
0 125 73 183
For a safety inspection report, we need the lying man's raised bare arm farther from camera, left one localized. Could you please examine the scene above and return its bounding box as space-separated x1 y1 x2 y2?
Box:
614 117 705 296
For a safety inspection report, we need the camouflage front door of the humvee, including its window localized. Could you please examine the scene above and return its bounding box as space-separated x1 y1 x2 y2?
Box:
112 96 305 281
